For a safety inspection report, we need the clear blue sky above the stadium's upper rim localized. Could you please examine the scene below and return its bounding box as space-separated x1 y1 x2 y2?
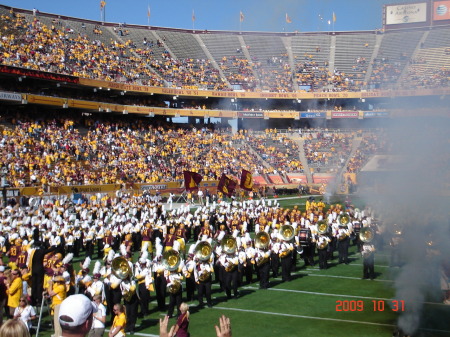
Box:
0 0 418 32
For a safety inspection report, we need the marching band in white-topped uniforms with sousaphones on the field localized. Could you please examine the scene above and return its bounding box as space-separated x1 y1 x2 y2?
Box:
0 194 376 322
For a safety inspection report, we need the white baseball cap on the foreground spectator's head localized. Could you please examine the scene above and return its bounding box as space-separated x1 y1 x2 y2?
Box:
58 294 97 327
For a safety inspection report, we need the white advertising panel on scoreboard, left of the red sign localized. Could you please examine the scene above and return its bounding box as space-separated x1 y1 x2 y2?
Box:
386 2 427 25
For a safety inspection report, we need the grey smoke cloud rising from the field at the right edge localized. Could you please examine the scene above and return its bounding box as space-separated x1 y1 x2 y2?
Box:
361 113 450 335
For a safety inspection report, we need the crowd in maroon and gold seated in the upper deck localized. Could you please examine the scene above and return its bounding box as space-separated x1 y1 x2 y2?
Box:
0 6 448 92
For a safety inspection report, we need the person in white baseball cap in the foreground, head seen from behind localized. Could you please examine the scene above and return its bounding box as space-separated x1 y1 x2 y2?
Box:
59 294 98 337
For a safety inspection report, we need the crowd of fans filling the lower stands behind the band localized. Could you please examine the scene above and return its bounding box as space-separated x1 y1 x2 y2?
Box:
0 114 386 191
